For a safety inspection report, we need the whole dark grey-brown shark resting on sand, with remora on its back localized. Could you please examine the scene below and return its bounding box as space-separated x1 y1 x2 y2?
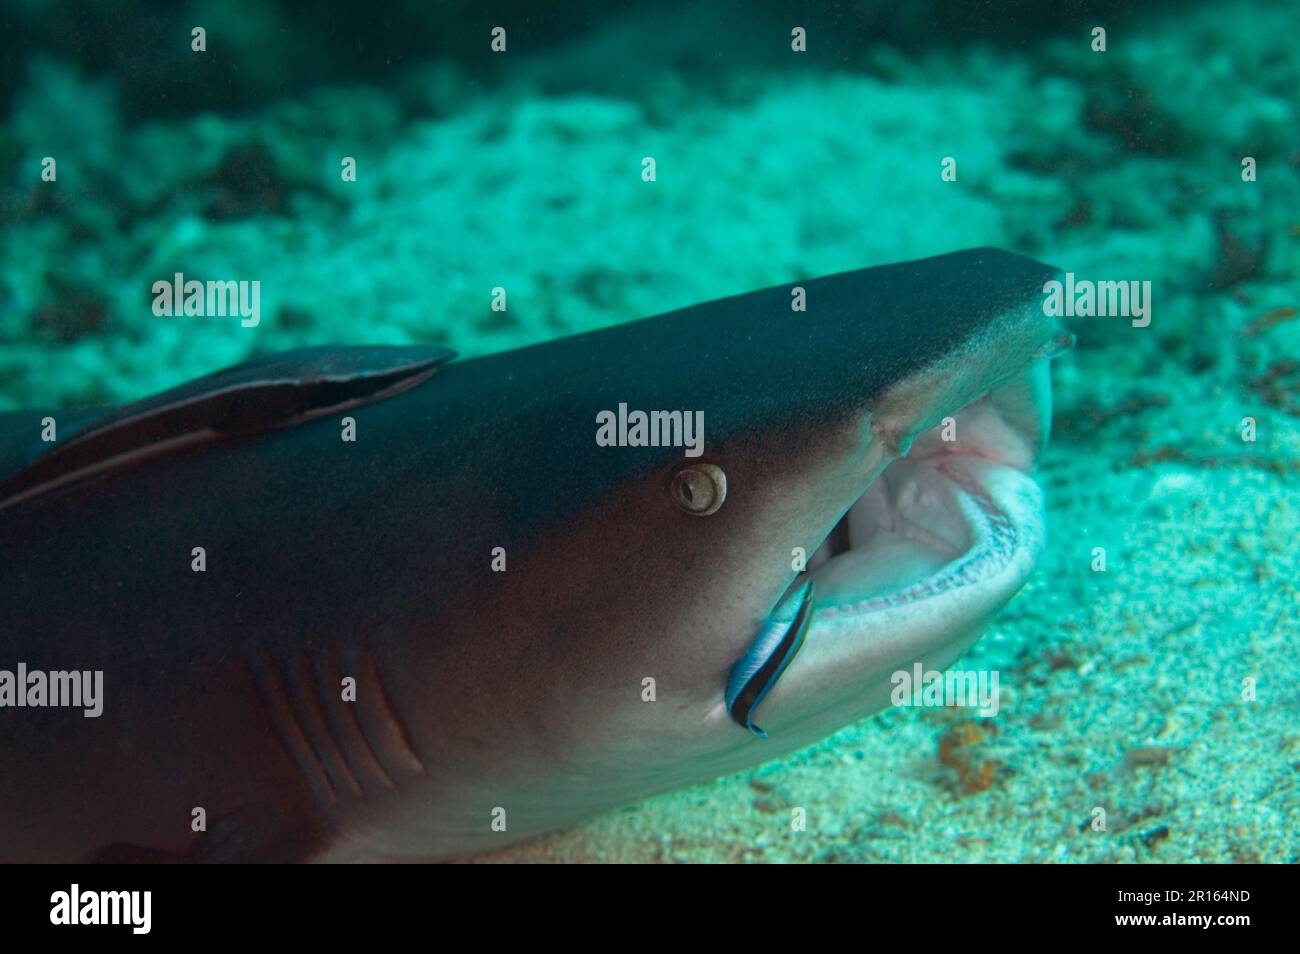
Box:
0 248 1070 862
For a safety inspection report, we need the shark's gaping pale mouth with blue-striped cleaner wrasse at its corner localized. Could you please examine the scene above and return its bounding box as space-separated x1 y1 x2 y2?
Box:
724 361 1050 737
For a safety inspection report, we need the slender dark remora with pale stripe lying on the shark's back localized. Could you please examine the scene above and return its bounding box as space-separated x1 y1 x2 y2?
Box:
0 344 455 509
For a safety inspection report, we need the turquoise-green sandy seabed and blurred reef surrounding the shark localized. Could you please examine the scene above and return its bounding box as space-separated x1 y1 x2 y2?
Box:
0 0 1300 863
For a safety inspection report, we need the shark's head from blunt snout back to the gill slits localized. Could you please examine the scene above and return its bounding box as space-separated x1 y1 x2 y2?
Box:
299 248 1070 857
